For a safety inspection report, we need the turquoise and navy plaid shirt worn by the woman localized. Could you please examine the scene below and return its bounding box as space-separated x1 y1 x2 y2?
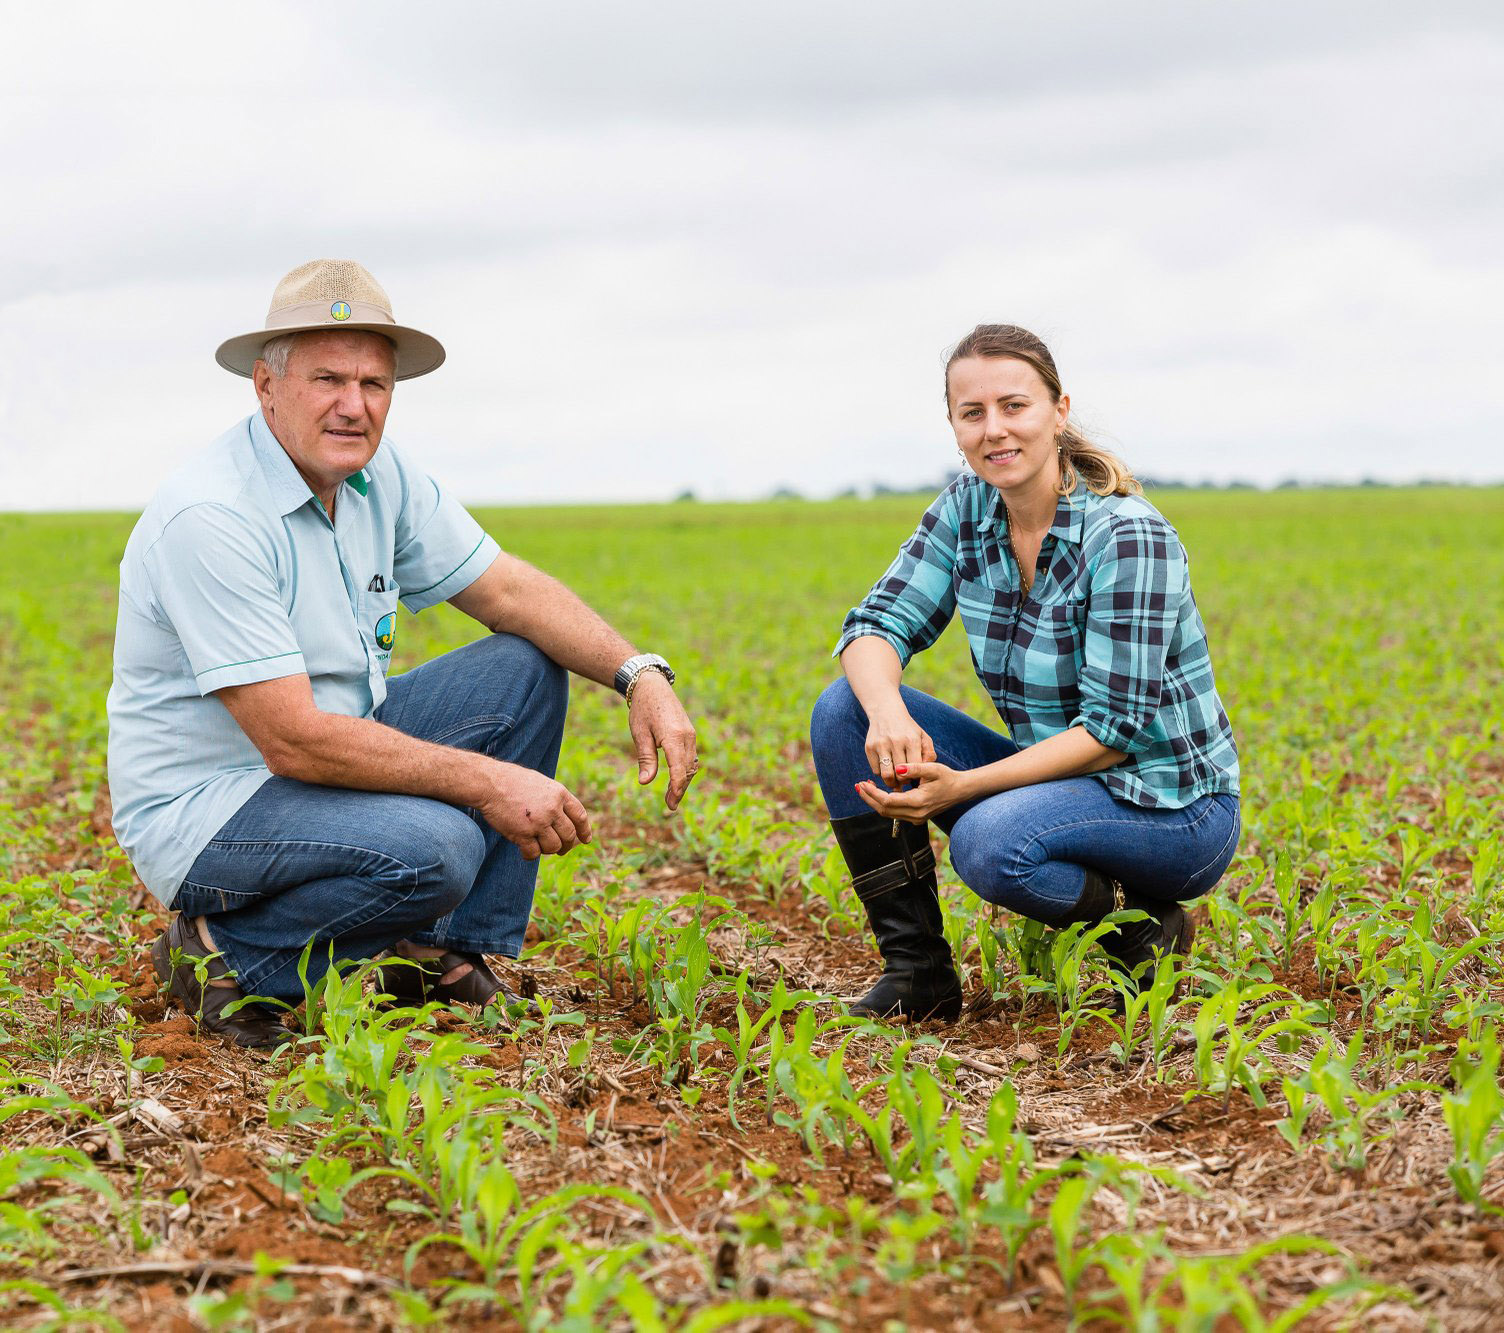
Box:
836 472 1238 808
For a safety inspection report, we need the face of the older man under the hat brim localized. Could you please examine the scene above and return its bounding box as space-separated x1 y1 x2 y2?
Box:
253 331 397 509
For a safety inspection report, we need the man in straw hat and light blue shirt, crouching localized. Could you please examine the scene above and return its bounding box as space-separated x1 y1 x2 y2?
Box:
108 260 696 1049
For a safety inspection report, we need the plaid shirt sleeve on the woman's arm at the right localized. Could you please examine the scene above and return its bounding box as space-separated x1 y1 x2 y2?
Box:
1072 518 1187 754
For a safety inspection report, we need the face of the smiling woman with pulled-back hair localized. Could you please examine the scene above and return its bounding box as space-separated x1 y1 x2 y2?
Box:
946 357 1071 493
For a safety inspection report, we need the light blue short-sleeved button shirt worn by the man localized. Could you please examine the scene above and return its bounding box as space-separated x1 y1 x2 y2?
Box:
108 412 501 904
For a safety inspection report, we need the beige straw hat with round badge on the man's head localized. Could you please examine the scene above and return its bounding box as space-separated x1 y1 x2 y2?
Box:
214 259 444 379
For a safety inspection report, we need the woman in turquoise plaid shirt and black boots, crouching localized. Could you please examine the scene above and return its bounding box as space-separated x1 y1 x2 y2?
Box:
811 323 1239 1020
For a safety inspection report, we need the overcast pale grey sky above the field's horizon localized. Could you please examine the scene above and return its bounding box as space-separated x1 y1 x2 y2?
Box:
0 0 1504 509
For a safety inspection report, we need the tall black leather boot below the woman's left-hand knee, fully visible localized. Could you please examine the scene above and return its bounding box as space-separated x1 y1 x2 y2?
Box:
830 814 961 1022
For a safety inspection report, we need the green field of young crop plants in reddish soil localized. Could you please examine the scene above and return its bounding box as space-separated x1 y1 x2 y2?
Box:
0 489 1504 1330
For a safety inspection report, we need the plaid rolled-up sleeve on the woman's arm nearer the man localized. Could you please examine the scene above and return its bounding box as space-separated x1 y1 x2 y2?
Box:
832 490 957 667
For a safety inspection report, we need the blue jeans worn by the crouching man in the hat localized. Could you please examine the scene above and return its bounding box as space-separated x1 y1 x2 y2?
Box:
173 633 569 1001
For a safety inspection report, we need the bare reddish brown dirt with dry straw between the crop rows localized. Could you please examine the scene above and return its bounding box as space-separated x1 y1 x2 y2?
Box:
0 770 1504 1333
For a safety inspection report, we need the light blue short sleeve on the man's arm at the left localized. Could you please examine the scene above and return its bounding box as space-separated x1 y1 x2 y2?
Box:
144 504 307 695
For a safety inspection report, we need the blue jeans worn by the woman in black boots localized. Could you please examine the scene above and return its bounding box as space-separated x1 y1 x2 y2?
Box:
811 680 1241 921
